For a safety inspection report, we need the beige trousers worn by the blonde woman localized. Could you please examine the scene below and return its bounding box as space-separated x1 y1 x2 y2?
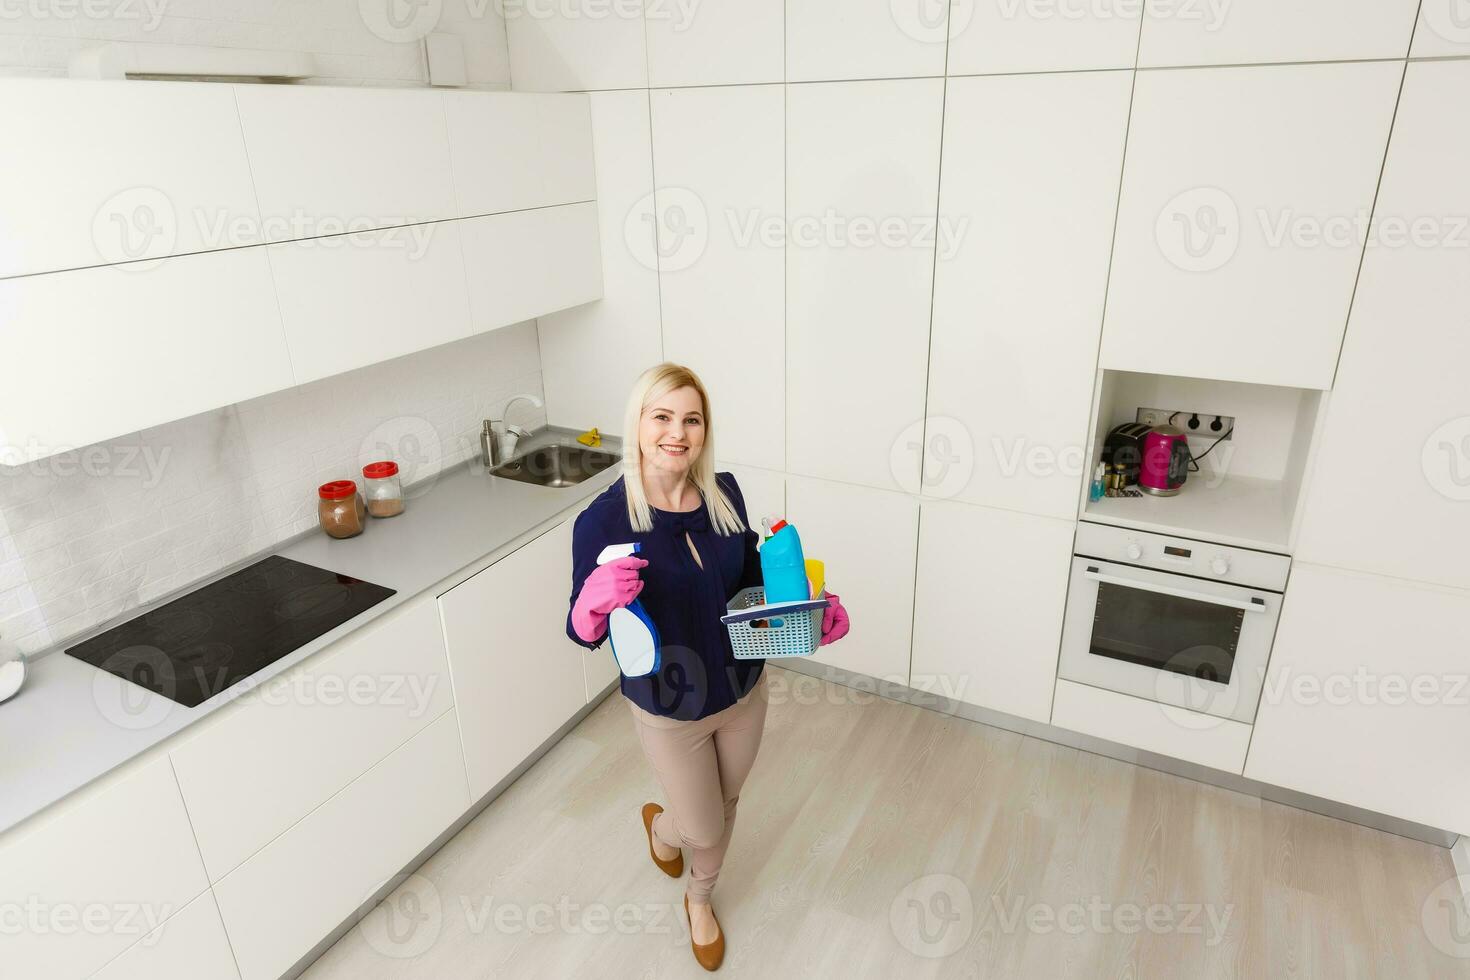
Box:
628 670 770 905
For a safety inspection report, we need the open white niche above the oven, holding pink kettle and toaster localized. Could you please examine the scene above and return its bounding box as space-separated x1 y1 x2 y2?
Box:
1080 370 1329 554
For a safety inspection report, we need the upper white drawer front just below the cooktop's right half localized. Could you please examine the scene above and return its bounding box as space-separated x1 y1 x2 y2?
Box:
172 598 453 882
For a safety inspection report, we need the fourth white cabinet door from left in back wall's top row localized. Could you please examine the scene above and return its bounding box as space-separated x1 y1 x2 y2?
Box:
946 0 1142 74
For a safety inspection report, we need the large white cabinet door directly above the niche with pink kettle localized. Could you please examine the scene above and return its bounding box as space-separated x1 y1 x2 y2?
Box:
1101 63 1404 388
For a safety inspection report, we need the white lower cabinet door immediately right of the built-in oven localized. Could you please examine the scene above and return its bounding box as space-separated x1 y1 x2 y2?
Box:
1245 561 1470 833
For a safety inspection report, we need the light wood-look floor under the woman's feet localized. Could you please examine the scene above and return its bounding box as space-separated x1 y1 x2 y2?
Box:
304 666 1470 980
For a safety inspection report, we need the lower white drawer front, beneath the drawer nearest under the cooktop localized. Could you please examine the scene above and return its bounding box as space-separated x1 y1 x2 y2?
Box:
215 710 469 980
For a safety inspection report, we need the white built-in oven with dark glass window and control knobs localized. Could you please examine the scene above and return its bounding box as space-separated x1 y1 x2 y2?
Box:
1057 522 1291 724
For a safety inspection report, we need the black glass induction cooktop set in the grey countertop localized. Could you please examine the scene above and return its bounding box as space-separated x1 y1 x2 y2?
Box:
66 555 394 708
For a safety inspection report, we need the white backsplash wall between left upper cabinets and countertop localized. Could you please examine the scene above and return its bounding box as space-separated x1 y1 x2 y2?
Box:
0 322 545 654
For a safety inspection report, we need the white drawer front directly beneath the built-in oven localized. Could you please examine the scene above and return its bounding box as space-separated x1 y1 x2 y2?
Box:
1051 679 1251 774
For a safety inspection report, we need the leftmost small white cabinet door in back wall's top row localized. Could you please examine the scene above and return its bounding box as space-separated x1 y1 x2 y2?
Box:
506 0 648 93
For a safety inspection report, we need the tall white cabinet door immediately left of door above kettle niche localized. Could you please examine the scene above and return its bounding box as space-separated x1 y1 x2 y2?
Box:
934 72 1132 517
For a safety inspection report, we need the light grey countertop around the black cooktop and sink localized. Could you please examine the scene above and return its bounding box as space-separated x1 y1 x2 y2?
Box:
0 428 622 833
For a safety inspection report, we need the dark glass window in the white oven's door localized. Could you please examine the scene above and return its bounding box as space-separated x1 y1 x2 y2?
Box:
1089 582 1245 685
